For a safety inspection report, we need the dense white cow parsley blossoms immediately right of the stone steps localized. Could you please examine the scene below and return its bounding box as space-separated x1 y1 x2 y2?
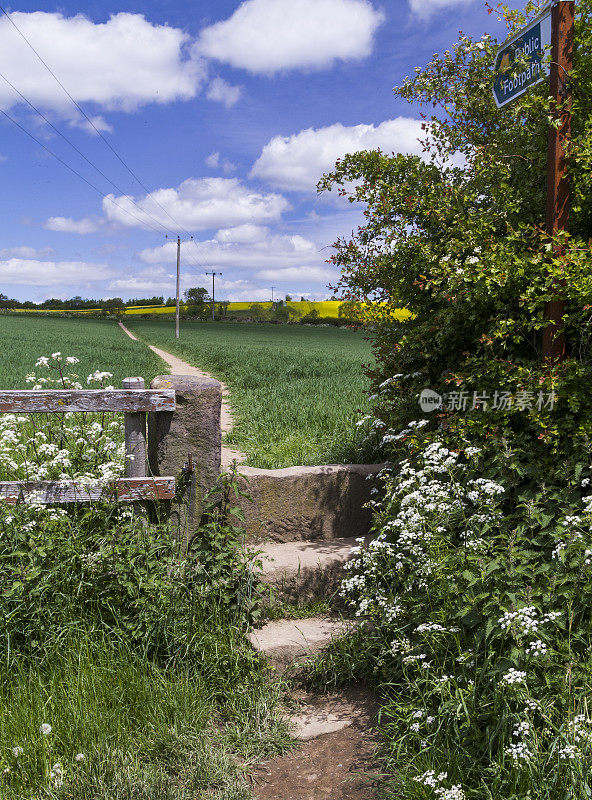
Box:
341 440 504 634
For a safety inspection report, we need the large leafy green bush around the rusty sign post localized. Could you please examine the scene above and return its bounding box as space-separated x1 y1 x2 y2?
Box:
319 0 592 468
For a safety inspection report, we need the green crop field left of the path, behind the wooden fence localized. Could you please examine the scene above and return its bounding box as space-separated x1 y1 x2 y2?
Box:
0 315 166 389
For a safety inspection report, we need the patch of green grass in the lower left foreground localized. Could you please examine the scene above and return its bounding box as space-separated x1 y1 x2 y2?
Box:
0 629 289 800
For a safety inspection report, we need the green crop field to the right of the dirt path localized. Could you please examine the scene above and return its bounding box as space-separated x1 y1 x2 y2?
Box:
128 320 372 469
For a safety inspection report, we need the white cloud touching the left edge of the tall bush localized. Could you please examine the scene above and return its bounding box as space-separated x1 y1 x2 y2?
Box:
251 117 422 191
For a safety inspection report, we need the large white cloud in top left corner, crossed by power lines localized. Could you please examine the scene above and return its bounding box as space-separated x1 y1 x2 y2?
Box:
0 11 206 115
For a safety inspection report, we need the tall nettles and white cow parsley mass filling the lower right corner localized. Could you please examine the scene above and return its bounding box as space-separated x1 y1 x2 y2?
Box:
342 438 592 800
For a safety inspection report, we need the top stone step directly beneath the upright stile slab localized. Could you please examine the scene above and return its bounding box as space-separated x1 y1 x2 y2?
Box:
252 537 357 602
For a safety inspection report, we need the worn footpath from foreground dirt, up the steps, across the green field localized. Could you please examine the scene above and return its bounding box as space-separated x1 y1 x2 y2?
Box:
119 322 377 800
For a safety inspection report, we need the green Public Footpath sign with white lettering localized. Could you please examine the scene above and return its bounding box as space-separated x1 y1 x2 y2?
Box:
493 7 552 108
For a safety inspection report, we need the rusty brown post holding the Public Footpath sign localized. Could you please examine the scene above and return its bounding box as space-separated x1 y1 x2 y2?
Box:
543 0 575 361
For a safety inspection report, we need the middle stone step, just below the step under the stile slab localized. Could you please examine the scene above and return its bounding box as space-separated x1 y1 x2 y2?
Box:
249 617 355 671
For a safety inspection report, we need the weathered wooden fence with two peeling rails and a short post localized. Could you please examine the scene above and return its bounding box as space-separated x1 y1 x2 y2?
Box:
0 378 176 505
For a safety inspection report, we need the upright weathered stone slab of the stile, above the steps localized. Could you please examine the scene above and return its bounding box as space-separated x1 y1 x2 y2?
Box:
239 464 385 542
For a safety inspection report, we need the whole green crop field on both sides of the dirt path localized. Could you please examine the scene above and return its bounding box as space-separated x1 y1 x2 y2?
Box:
0 315 371 468
